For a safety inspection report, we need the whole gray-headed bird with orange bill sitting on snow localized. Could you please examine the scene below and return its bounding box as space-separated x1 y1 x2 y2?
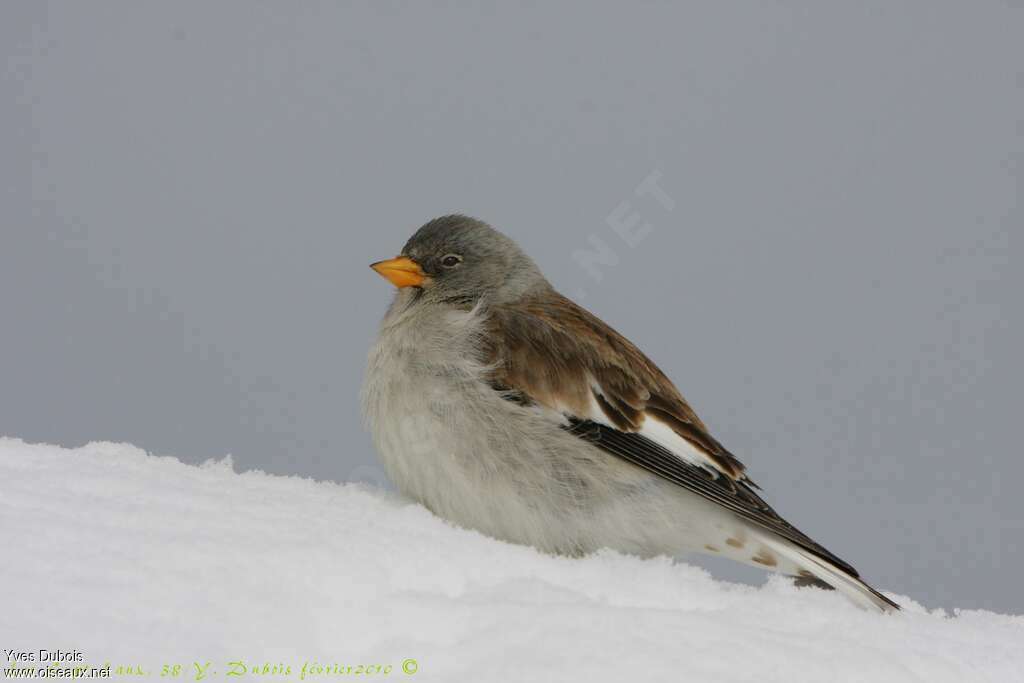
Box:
360 214 899 612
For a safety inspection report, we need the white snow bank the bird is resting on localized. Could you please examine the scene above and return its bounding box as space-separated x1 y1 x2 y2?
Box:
0 438 1024 683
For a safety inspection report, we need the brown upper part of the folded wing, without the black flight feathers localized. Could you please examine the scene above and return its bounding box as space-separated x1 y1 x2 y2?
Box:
487 295 753 483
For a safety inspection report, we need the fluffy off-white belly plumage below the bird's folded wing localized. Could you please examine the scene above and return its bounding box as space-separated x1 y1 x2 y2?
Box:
365 348 739 556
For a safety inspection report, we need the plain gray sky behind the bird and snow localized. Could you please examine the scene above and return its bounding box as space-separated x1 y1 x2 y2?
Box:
0 1 1024 612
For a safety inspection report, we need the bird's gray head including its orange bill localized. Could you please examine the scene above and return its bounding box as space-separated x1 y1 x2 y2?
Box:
371 215 550 304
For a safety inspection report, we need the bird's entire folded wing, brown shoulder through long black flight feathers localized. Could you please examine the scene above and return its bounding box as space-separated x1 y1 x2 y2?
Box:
487 290 857 577
